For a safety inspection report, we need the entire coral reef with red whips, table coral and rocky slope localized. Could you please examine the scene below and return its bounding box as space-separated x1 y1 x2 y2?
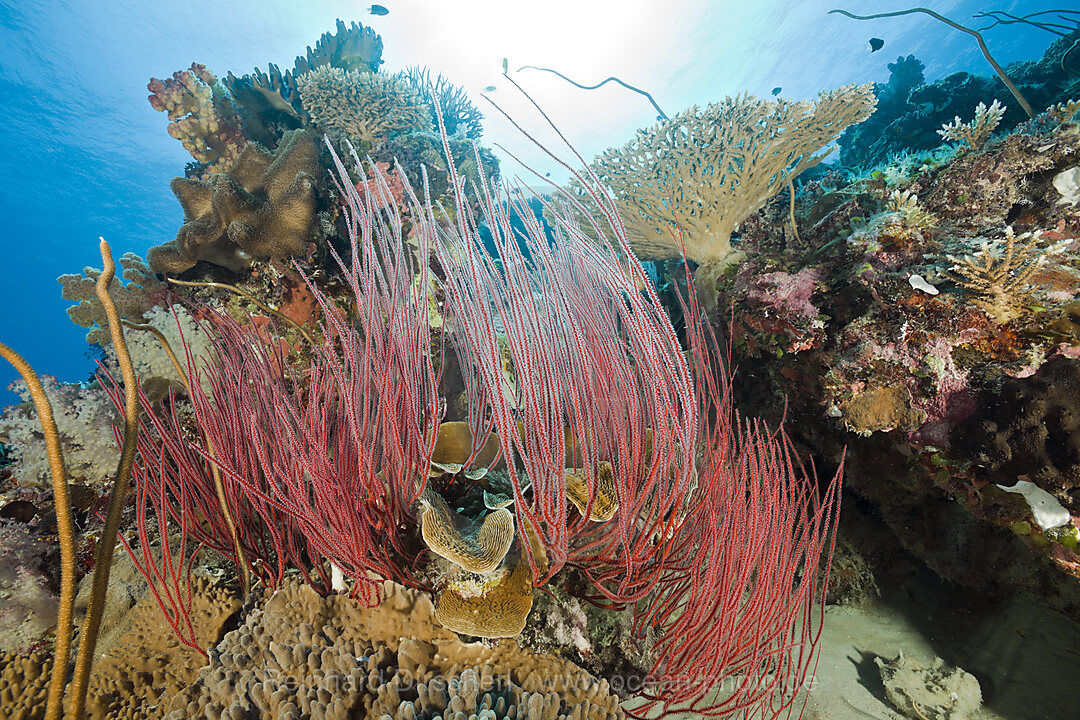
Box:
0 8 1080 720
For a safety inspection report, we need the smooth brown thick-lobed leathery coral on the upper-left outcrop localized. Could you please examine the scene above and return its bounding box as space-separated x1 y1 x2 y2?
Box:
147 131 321 274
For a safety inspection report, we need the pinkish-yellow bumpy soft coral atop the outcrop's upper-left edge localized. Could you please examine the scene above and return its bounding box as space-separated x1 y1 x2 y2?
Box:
146 63 247 173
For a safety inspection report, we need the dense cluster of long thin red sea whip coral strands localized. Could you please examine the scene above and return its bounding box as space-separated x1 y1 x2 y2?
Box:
122 99 839 717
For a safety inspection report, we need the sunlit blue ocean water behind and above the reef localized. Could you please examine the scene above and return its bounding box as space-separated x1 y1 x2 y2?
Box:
0 0 1061 405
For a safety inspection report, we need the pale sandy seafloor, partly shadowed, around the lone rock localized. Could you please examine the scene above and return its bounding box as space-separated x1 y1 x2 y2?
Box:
804 575 1080 720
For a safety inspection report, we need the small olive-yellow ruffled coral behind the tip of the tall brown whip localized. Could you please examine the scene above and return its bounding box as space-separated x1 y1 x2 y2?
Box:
56 253 165 345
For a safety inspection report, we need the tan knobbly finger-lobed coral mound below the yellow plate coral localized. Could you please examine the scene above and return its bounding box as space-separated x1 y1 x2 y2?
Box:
165 583 623 720
